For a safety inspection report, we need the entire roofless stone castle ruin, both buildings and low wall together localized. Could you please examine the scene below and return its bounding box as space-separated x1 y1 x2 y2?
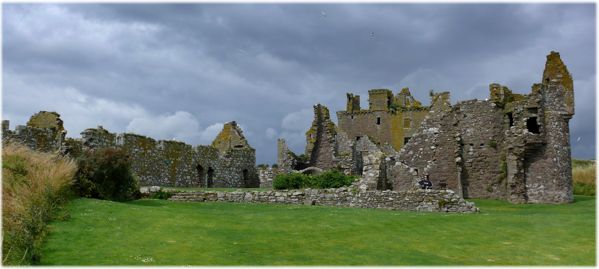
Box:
2 52 574 206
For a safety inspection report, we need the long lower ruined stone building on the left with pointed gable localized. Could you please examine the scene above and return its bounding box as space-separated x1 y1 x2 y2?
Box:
2 111 259 187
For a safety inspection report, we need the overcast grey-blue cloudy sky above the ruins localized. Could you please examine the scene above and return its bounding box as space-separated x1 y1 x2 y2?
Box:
2 4 596 163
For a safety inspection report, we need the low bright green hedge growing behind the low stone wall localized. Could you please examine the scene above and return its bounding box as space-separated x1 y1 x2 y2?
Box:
272 171 356 190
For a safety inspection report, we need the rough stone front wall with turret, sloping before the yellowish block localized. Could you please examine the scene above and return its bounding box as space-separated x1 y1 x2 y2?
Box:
387 52 574 203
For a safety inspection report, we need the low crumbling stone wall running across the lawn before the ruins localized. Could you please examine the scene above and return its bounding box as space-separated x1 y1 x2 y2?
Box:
169 188 479 213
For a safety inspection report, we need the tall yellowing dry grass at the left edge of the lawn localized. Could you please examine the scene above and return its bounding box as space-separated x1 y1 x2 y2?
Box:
2 144 77 265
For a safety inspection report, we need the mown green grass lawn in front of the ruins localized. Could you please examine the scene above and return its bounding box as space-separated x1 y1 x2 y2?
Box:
41 196 596 265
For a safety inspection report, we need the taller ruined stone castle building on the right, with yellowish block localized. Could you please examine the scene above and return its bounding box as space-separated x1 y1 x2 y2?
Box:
278 52 574 203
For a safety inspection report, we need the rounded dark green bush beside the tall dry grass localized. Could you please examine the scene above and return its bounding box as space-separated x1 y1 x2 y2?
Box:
74 148 139 201
